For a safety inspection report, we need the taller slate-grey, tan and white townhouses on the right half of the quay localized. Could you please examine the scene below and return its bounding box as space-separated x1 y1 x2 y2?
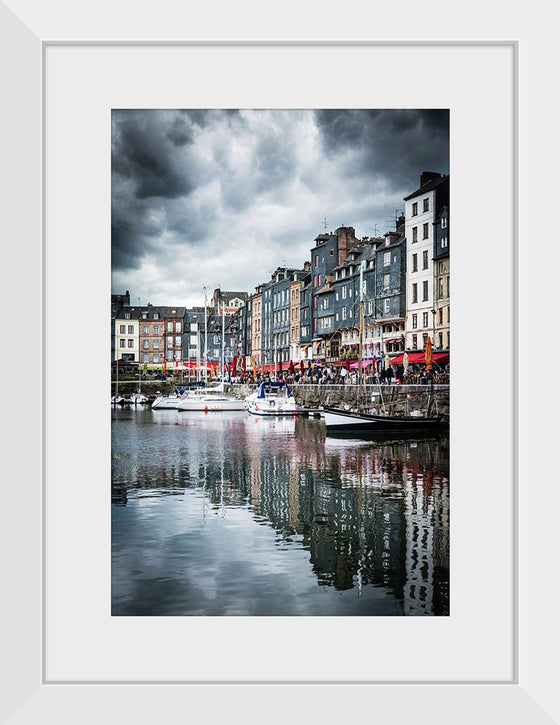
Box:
230 172 450 365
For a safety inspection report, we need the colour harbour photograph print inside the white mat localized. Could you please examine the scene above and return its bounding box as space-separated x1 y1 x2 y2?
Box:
112 109 451 617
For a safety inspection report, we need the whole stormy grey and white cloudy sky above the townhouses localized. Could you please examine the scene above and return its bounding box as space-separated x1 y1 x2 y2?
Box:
111 109 449 307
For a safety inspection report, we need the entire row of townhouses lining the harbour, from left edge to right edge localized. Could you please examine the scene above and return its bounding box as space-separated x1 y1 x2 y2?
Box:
112 172 450 369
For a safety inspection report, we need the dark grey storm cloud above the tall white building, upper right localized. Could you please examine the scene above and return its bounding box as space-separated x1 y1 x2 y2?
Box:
315 109 449 191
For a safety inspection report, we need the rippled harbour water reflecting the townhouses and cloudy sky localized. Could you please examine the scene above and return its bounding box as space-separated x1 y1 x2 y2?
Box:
111 407 449 616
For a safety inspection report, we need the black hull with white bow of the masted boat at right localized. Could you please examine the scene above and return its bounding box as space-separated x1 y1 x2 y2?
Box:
323 406 448 436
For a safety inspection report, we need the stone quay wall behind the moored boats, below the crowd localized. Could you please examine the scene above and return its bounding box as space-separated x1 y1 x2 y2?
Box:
111 380 449 416
